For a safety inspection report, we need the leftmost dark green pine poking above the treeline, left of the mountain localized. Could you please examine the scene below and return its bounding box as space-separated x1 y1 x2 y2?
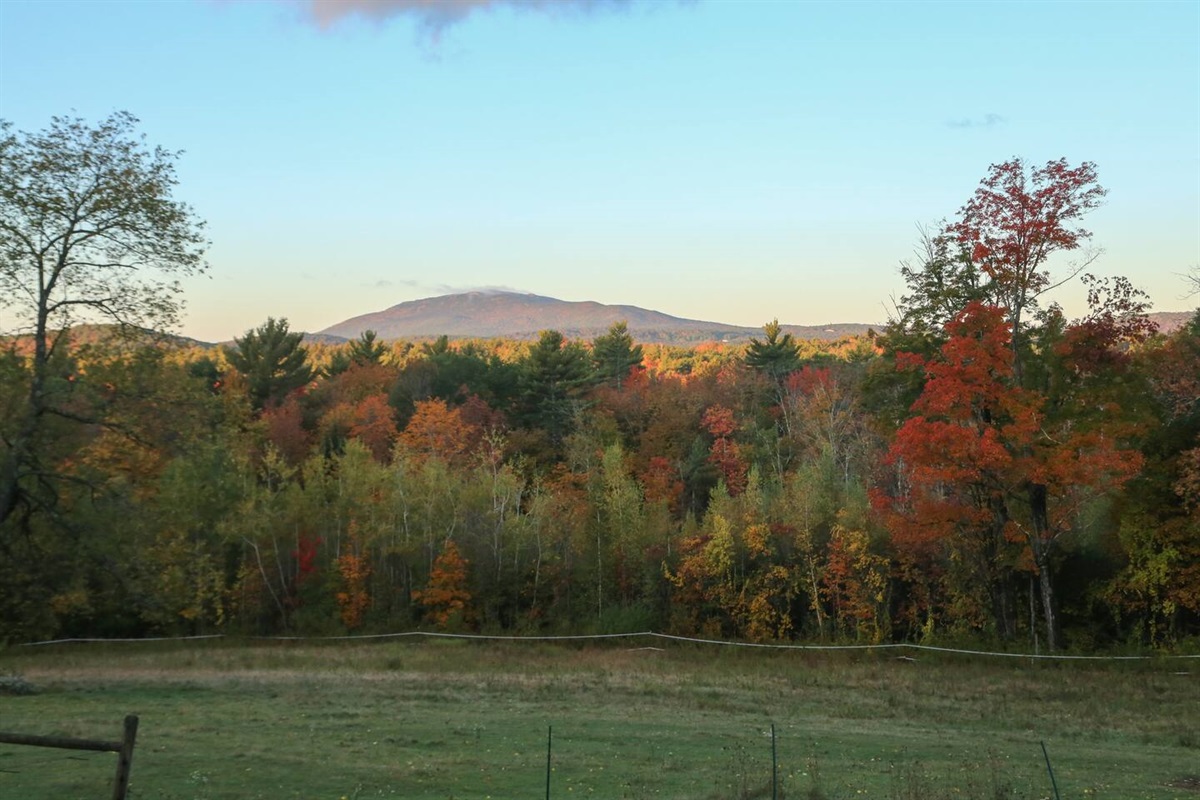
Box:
226 317 312 409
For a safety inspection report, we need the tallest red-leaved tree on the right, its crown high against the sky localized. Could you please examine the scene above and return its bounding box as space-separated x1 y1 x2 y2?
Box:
870 158 1150 646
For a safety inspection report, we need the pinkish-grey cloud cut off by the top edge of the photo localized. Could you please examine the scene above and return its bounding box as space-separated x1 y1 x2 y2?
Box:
294 0 632 38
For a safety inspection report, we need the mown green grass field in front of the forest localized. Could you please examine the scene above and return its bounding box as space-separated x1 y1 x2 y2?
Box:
0 639 1200 800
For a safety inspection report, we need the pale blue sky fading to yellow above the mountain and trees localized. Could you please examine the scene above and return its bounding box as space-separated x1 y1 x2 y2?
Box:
0 0 1200 341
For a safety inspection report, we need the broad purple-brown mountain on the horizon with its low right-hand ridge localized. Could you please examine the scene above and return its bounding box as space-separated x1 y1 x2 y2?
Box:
319 291 870 344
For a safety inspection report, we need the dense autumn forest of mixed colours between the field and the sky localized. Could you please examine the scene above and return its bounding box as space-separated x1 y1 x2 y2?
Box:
0 114 1200 652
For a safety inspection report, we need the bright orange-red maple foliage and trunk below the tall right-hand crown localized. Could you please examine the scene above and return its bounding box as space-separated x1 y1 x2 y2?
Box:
890 302 1141 650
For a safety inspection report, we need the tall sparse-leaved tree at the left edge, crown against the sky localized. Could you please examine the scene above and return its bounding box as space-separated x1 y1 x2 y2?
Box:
0 113 206 522
